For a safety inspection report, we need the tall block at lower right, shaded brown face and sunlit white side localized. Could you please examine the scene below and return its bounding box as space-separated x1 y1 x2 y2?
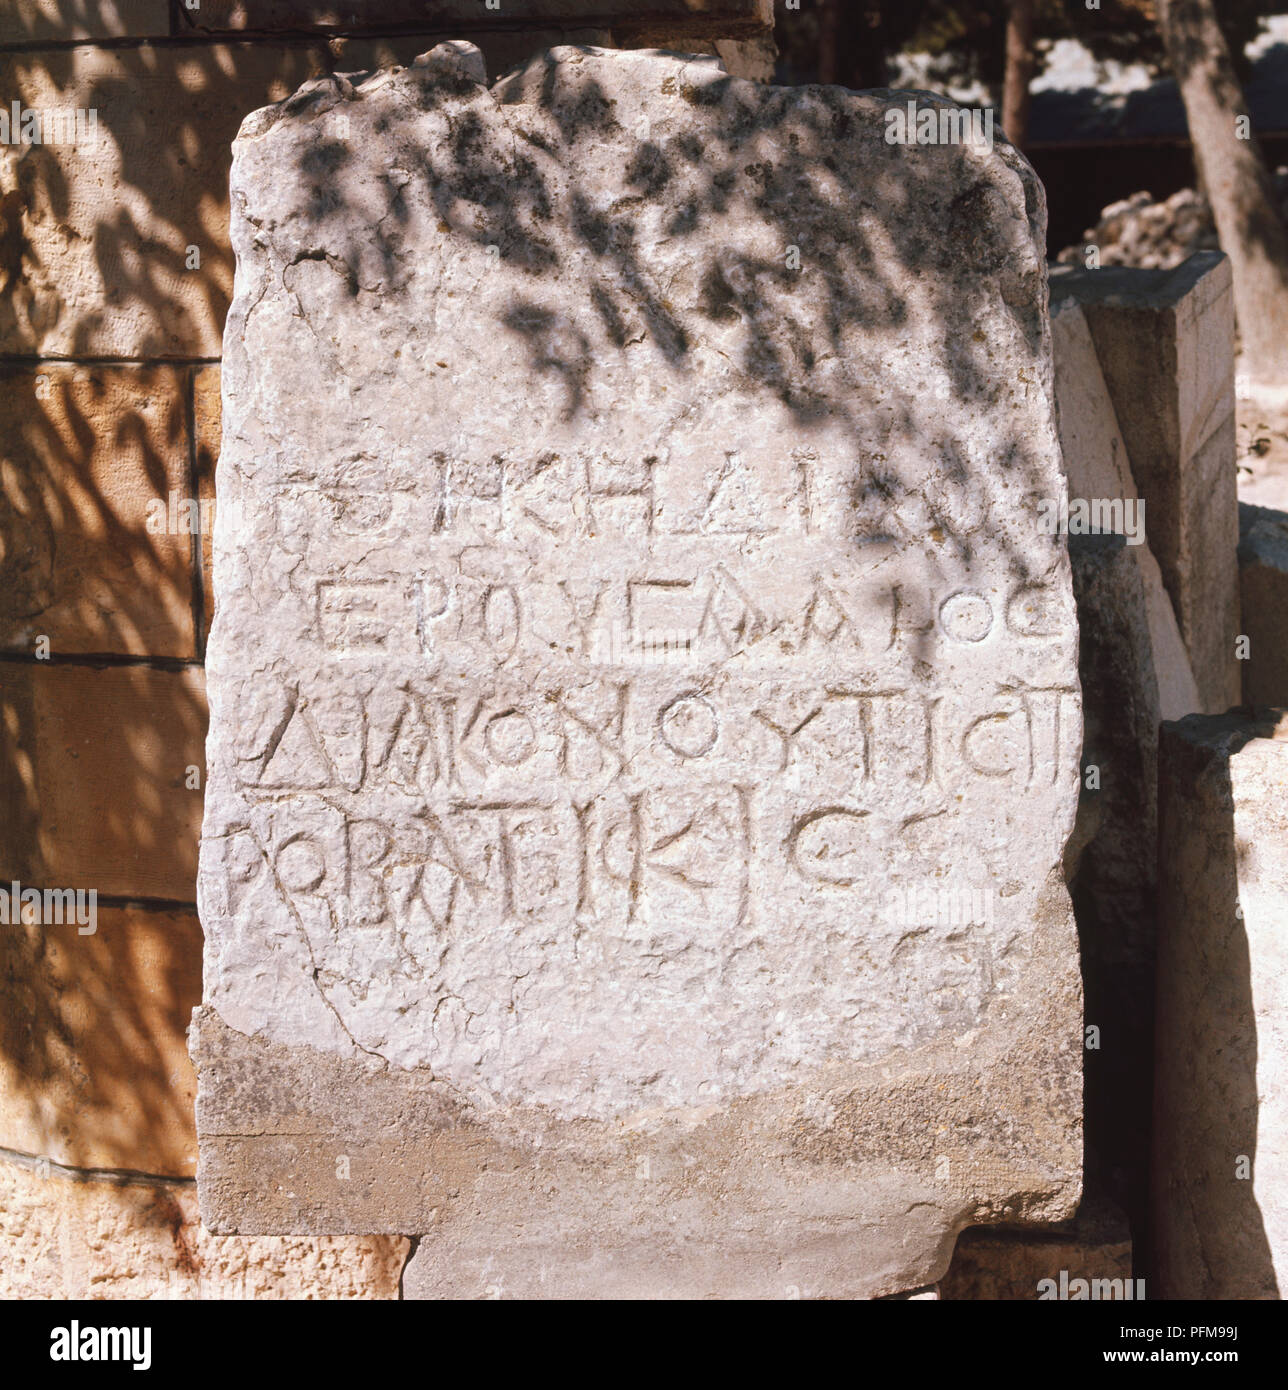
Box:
1150 710 1288 1298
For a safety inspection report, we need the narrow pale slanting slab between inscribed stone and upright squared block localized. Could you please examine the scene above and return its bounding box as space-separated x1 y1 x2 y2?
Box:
1050 296 1199 719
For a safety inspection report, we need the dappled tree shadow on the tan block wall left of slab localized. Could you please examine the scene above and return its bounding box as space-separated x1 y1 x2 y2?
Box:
0 35 439 1170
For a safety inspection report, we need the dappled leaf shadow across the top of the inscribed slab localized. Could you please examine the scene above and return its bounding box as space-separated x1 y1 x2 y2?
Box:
275 50 1078 659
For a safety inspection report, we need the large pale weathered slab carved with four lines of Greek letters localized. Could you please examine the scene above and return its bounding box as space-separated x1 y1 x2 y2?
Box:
193 44 1081 1297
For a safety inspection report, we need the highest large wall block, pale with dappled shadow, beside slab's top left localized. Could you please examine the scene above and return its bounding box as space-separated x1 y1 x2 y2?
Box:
0 36 610 357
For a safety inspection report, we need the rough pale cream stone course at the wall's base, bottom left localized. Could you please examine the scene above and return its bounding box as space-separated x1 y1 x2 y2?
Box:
0 1162 408 1300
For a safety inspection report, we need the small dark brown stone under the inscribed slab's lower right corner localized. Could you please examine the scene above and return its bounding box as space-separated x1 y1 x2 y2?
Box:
939 1201 1133 1301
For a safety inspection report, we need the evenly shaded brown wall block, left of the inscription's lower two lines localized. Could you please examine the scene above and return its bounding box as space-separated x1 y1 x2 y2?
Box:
0 662 206 902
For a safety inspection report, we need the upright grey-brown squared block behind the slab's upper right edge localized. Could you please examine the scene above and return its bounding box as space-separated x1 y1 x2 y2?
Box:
1052 252 1239 713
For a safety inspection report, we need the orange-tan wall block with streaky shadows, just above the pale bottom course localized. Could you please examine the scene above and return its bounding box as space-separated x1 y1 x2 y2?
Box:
0 885 201 1177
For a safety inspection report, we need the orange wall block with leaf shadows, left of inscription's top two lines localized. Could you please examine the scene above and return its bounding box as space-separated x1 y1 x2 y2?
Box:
0 363 196 656
